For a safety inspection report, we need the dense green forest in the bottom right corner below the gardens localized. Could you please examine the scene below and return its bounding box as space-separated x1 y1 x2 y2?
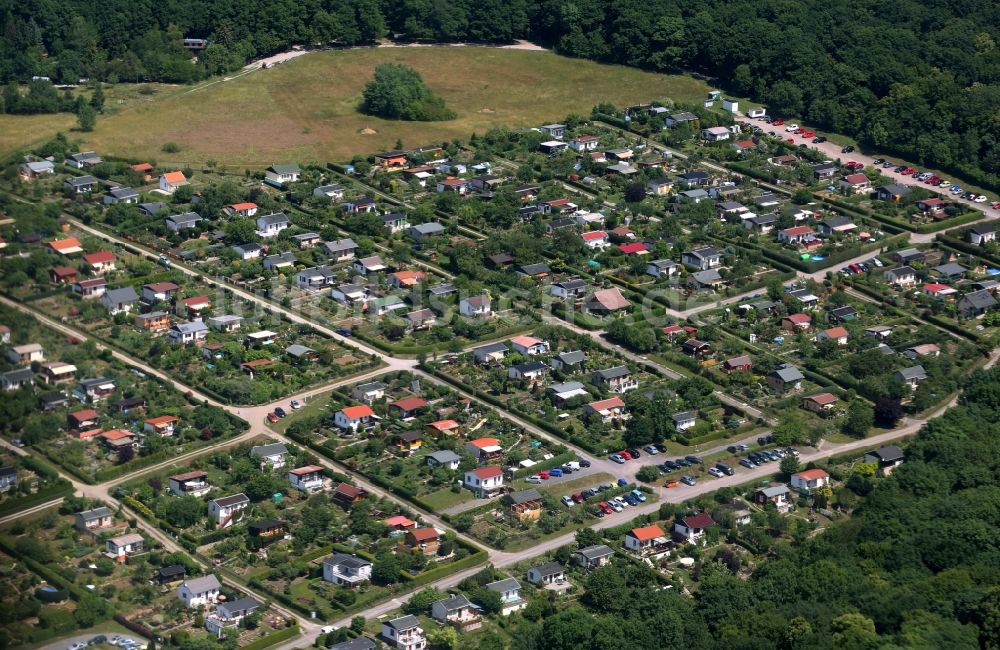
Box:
472 369 1000 650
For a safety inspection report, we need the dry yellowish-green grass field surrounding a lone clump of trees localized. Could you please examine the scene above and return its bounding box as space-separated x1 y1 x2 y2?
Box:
0 47 708 167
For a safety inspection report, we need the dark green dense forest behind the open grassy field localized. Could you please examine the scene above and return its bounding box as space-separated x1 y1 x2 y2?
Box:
0 0 1000 182
